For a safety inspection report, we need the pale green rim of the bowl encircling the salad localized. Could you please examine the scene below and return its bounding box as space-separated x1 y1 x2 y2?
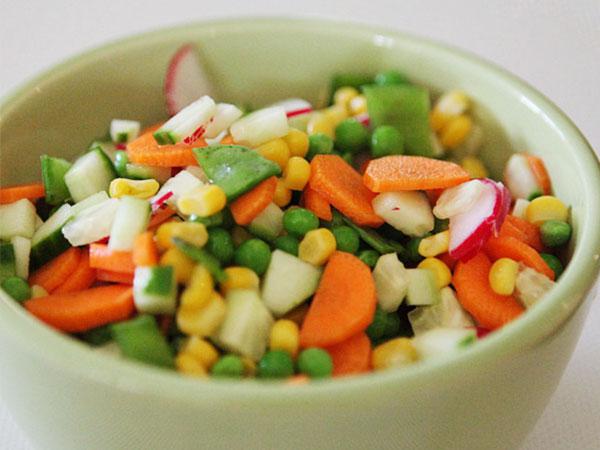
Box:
0 17 600 404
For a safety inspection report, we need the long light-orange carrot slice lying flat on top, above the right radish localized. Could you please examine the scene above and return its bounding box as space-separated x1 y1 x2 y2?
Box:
364 156 471 192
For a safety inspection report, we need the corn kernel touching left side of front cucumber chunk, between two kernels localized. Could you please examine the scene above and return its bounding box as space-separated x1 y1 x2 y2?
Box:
177 292 227 337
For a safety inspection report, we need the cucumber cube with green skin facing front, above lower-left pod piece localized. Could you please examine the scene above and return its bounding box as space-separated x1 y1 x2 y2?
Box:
133 266 177 314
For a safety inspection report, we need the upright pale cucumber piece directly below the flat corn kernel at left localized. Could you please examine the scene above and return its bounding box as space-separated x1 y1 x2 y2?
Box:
108 196 152 251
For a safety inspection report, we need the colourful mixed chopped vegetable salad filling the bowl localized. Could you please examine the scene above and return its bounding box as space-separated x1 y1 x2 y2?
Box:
0 46 571 383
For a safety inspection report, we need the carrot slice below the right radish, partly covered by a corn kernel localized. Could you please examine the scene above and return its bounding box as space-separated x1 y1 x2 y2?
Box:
452 252 524 330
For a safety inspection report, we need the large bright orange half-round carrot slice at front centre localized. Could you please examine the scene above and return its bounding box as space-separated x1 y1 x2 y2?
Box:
300 252 376 347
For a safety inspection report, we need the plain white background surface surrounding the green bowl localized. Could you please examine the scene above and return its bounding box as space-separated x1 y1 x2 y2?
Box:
0 0 600 450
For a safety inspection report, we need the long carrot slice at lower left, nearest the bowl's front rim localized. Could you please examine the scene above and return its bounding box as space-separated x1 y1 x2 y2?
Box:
24 286 135 333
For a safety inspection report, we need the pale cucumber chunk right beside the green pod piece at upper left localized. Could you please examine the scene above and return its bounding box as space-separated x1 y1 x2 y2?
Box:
65 148 117 202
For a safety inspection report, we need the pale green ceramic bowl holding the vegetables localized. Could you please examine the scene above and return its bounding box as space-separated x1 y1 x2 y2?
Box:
0 19 600 450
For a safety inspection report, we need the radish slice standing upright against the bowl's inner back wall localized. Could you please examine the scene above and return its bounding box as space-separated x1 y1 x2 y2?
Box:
164 44 214 116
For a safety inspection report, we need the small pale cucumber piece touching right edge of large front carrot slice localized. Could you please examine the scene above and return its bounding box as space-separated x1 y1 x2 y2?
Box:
373 253 410 312
